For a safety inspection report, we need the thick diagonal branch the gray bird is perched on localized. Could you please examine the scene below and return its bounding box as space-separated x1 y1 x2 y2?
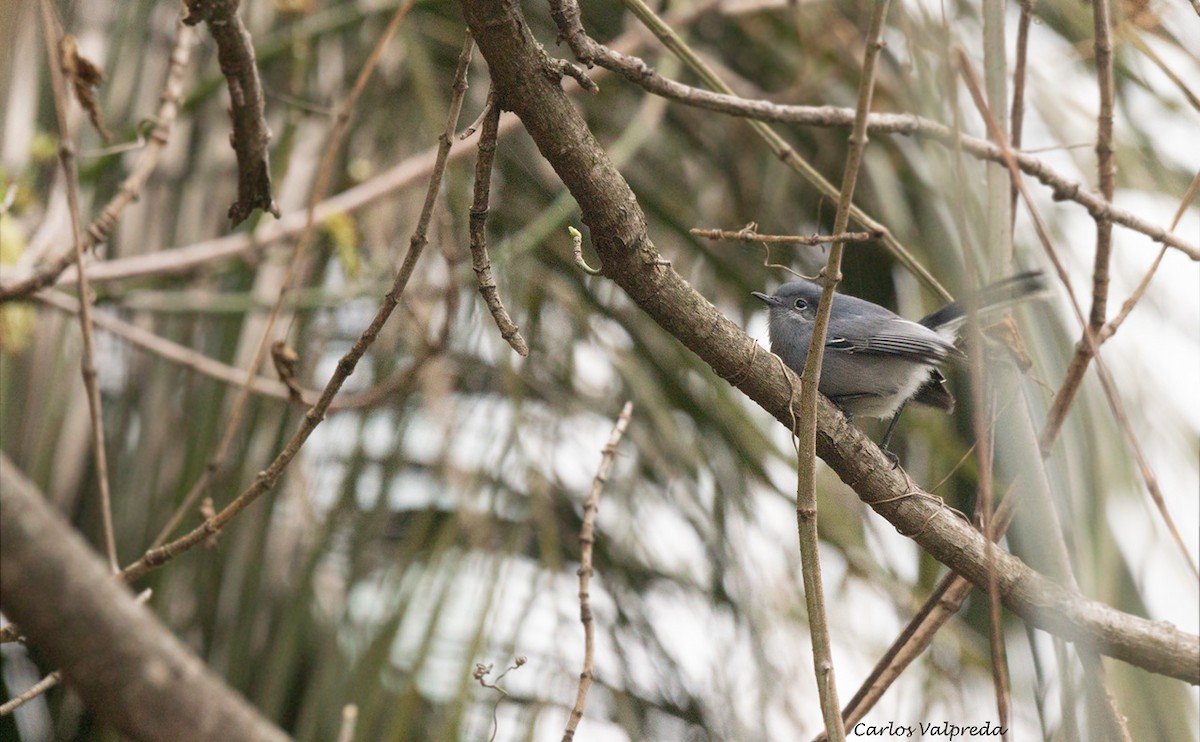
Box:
463 0 1200 684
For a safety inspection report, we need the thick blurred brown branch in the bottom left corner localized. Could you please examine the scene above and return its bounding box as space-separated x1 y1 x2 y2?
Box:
0 454 288 742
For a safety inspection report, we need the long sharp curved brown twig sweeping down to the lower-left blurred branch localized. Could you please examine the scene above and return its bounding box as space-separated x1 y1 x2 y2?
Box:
121 35 472 582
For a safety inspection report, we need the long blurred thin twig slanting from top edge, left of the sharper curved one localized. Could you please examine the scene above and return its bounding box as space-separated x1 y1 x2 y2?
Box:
150 0 414 549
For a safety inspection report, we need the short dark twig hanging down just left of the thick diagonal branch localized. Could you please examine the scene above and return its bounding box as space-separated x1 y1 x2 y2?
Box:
463 89 529 357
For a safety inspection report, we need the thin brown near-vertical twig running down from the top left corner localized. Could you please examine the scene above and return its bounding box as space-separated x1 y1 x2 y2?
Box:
40 0 120 572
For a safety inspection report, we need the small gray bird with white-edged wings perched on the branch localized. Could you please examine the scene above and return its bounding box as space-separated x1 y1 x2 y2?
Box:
754 271 1045 450
